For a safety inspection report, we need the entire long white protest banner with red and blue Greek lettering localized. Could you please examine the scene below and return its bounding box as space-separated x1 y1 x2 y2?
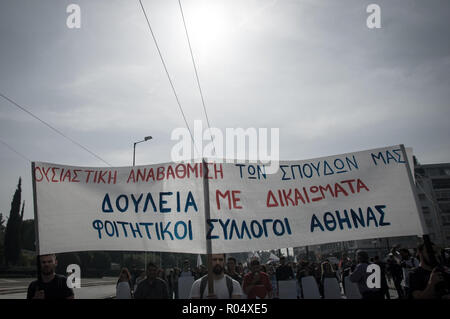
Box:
33 146 423 254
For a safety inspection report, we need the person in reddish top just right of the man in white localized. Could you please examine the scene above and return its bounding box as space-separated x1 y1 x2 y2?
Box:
242 258 273 299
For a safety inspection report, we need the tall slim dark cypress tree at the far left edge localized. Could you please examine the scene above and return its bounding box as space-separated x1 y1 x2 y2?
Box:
5 178 25 266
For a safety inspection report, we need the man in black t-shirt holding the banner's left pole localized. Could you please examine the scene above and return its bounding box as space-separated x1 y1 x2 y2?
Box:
27 254 75 299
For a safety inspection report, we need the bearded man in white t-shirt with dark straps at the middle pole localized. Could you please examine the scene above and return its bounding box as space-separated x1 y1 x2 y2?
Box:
189 254 242 299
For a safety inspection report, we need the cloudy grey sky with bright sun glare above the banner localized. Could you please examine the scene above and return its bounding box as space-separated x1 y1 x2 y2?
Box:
0 0 450 219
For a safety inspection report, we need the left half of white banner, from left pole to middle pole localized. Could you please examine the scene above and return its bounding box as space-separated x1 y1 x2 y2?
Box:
34 162 210 254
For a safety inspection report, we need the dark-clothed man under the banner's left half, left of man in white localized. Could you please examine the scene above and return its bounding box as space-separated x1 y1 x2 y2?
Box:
134 263 169 299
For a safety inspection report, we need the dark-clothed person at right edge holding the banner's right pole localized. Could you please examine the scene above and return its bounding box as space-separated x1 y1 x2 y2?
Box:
408 243 450 299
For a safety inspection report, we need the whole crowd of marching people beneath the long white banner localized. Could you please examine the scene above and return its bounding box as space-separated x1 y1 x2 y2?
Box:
28 244 450 299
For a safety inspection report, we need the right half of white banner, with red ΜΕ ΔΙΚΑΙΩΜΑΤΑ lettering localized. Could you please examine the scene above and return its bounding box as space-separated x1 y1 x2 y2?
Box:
207 146 424 253
